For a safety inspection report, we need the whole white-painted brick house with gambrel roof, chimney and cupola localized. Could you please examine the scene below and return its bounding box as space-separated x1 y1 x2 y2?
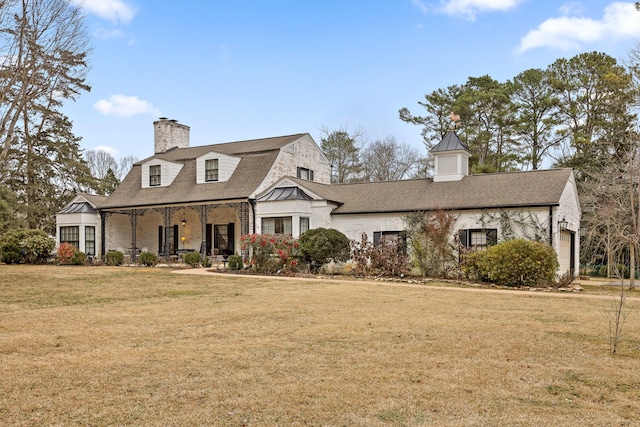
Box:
57 118 581 274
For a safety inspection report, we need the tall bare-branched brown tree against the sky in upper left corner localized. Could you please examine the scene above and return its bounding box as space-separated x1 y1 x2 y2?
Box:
0 0 90 169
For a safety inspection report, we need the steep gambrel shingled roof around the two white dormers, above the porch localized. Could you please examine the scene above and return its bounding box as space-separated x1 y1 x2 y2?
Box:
98 134 306 209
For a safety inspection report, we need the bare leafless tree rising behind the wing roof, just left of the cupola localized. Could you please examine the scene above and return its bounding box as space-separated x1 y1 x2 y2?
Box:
362 136 426 181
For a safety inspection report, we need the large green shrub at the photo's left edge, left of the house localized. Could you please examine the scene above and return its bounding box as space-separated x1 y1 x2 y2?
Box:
0 228 56 264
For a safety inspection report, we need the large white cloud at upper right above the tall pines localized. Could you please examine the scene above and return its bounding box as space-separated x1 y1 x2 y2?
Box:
518 2 640 53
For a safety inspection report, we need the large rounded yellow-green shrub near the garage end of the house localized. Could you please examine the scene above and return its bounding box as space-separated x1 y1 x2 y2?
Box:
465 239 558 286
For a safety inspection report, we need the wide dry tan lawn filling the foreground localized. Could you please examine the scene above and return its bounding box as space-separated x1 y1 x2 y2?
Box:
0 266 640 426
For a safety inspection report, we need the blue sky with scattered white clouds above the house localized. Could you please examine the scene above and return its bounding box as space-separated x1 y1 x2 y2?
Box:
64 0 640 159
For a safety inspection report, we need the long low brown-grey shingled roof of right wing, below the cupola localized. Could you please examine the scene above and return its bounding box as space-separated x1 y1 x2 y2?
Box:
292 169 572 214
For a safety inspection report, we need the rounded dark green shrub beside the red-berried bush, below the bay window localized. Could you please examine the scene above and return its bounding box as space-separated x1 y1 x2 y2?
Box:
298 228 351 270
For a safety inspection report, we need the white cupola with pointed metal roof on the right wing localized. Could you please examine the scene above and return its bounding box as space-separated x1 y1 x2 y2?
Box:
429 130 471 182
